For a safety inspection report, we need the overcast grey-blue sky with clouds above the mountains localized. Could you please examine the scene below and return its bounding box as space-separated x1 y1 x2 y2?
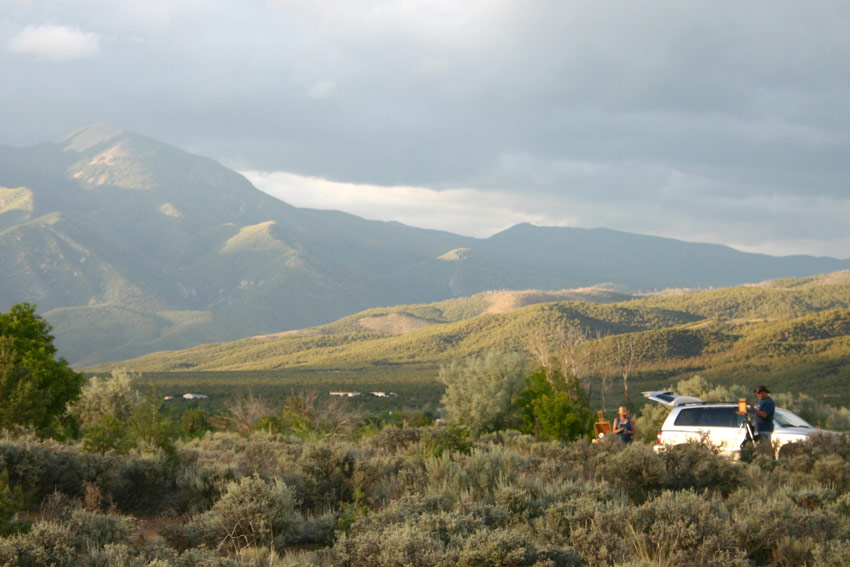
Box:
0 0 850 258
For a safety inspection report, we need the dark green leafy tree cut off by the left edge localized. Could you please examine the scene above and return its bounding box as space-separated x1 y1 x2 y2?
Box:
0 303 85 436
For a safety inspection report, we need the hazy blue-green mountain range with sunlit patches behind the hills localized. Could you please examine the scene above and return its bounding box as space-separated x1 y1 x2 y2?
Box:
0 124 850 366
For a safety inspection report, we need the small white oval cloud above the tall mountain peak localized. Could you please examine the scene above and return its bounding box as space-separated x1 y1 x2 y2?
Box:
8 25 99 61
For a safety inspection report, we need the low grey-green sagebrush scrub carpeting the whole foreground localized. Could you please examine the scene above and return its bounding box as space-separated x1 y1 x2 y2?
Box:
0 420 850 567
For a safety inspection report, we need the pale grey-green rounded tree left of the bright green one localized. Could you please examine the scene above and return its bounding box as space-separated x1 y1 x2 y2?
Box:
438 351 526 435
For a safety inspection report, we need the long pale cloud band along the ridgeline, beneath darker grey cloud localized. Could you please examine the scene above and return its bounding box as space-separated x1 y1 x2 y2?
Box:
241 168 850 258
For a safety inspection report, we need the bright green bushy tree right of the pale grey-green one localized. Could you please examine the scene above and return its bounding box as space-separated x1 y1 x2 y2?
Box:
517 367 594 441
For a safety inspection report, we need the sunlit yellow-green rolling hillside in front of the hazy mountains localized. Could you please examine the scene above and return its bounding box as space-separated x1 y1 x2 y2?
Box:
89 272 850 403
